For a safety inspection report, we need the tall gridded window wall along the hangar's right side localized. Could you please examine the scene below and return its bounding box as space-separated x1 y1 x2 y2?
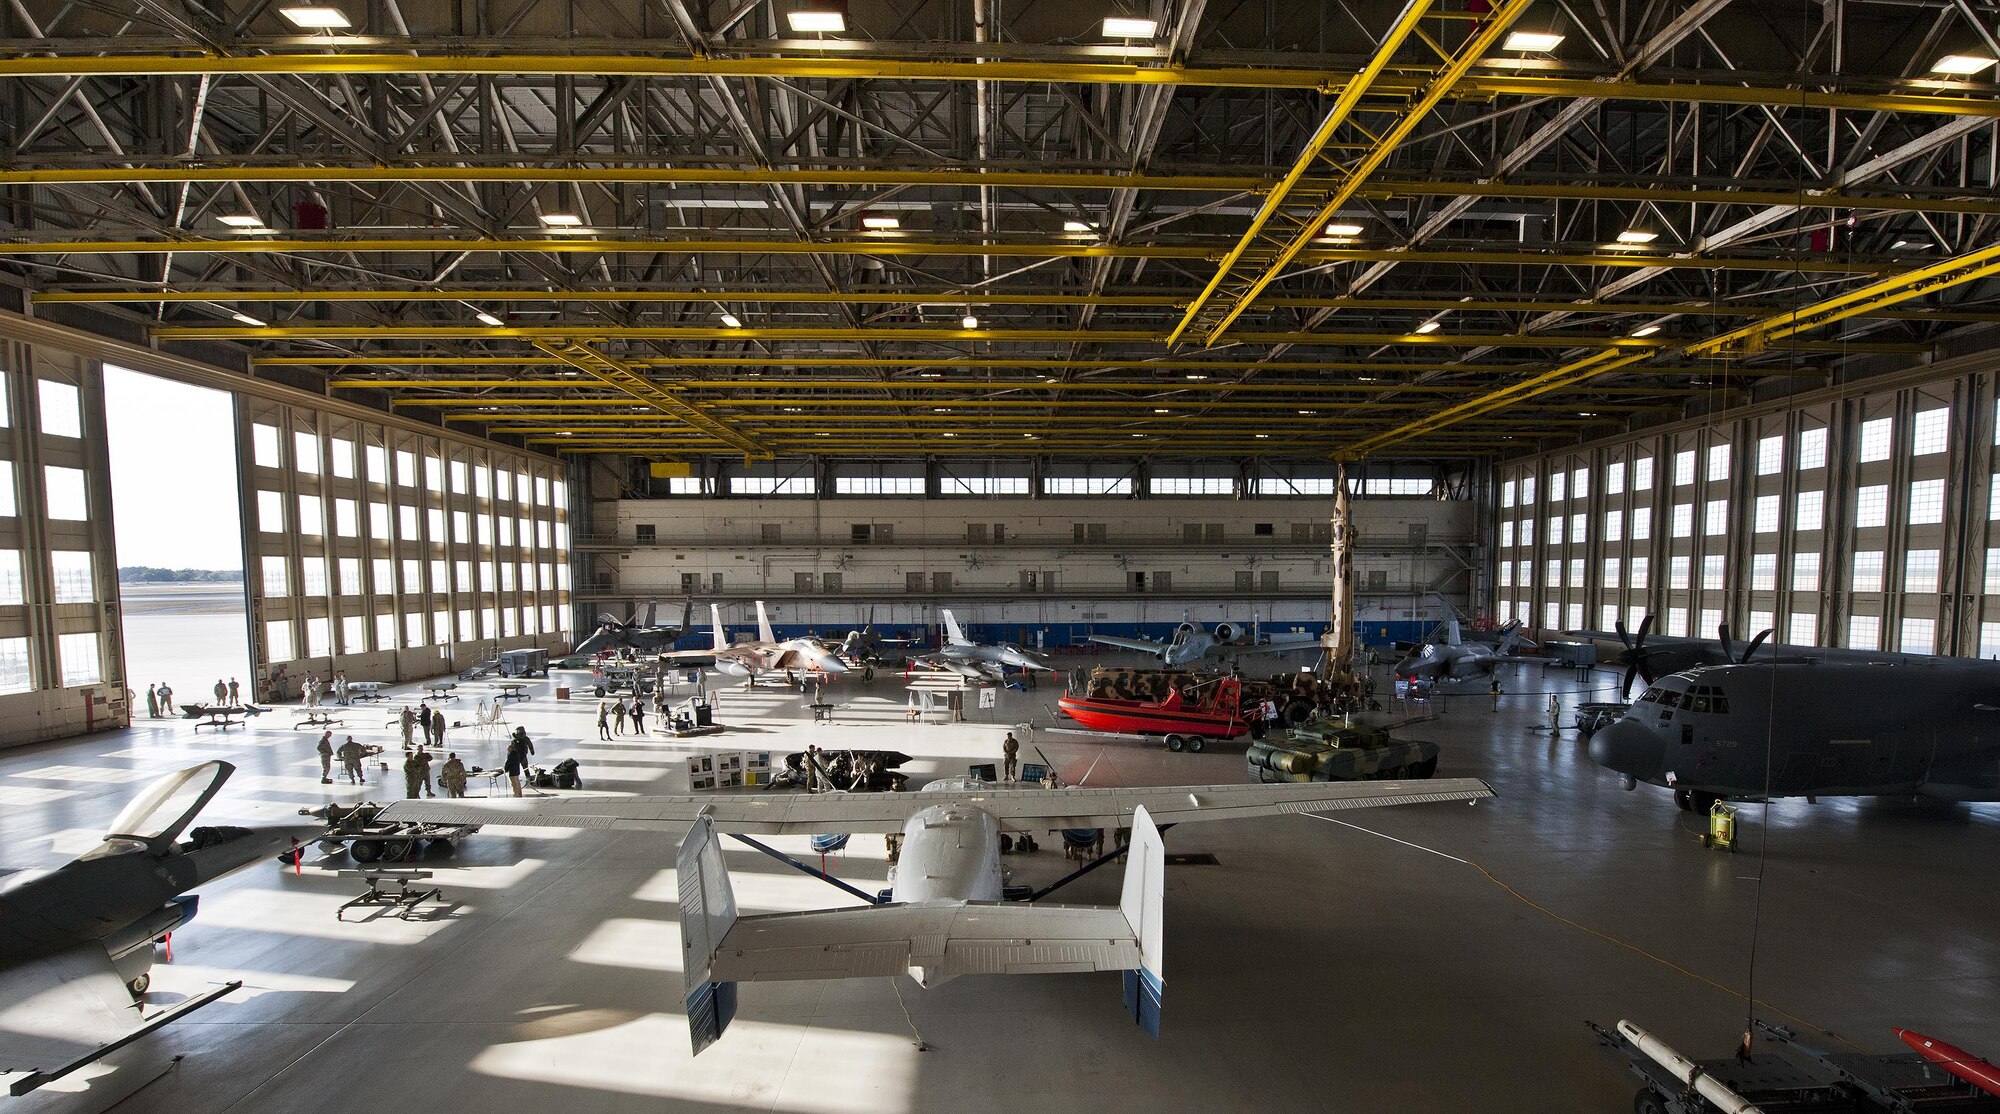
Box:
1494 372 2000 654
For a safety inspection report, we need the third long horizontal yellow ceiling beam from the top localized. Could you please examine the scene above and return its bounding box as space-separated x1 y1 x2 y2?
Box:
0 232 1898 274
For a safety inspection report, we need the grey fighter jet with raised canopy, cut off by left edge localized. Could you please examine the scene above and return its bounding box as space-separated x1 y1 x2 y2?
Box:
0 762 298 1096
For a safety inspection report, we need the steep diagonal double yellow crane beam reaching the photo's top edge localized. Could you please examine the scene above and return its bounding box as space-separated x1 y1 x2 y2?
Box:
1168 0 1534 348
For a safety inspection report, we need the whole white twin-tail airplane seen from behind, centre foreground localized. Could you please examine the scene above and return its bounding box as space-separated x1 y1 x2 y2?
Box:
382 778 1492 1052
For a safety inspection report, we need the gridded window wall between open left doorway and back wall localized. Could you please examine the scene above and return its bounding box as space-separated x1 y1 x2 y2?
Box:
238 398 570 700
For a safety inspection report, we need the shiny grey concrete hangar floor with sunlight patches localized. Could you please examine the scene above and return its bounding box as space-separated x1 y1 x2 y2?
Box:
0 658 2000 1114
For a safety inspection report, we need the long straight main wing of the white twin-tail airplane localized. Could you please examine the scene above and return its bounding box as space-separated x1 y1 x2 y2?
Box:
382 778 1492 836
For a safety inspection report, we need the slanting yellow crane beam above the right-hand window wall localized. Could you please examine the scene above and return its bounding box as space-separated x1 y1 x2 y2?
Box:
1340 244 2000 460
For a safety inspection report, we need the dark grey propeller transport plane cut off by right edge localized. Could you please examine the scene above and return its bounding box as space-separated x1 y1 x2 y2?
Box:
1590 658 2000 812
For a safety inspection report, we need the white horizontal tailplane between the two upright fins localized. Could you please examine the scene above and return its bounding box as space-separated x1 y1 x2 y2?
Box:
710 902 1140 982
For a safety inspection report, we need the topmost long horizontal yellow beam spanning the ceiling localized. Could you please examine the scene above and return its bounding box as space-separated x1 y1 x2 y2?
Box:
11 53 2000 116
